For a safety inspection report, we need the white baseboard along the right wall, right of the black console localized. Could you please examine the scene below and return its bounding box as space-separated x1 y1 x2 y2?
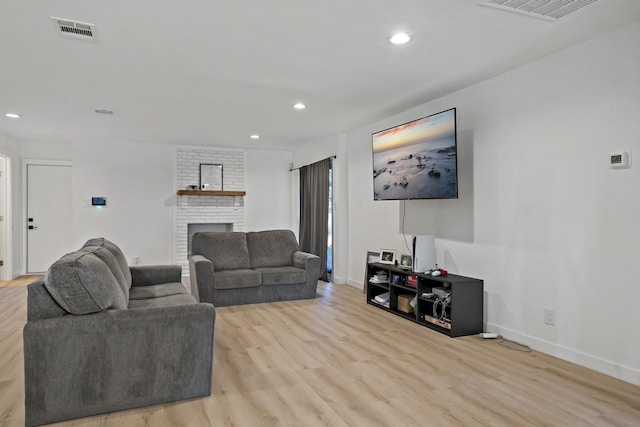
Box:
487 323 640 386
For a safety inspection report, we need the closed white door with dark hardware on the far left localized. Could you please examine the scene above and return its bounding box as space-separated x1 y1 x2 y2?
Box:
27 164 72 274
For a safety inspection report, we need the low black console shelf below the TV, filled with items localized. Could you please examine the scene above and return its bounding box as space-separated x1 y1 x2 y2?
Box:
365 263 484 337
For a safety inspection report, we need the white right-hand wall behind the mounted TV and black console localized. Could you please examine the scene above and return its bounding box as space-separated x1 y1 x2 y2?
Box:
324 24 640 384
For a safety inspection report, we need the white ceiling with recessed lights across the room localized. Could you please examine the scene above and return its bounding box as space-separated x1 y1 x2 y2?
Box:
0 0 640 149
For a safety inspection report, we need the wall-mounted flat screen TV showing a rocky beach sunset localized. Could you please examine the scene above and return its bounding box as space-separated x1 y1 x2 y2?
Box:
371 108 458 200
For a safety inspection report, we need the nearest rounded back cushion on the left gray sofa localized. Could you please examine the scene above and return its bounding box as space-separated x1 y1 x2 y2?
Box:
44 249 127 315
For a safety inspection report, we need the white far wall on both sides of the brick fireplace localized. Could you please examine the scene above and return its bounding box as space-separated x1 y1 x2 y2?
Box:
72 141 291 264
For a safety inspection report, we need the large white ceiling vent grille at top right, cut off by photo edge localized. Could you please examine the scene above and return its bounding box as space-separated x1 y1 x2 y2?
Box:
478 0 597 21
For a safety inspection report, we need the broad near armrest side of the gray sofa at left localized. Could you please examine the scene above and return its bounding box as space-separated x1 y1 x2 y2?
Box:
23 303 215 426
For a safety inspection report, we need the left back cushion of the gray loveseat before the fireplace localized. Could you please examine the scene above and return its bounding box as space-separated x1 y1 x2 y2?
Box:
191 231 251 271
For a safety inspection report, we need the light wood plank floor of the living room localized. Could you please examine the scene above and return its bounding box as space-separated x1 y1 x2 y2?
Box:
0 278 640 427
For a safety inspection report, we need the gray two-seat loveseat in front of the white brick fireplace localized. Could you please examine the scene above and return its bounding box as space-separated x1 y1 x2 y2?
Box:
189 230 320 307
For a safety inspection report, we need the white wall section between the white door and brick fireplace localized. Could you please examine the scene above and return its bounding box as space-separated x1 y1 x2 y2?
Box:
72 141 176 264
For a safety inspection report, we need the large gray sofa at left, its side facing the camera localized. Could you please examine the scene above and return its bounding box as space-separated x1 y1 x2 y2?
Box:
23 238 215 426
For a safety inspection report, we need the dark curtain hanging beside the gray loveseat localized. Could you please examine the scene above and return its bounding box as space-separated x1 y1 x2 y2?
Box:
300 158 331 281
